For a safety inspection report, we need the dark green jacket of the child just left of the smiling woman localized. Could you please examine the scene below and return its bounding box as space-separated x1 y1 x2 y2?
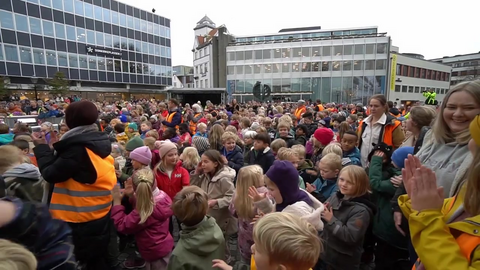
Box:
368 156 407 250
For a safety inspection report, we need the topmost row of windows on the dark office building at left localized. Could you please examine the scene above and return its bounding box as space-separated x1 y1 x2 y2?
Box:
3 0 170 33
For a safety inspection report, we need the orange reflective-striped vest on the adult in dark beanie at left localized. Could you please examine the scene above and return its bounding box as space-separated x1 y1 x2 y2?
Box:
50 148 117 223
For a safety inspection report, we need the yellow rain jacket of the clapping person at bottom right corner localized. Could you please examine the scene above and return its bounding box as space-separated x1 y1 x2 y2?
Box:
398 186 480 270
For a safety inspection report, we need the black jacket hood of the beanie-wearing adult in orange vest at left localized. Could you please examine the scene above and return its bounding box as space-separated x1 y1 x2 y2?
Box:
53 131 112 158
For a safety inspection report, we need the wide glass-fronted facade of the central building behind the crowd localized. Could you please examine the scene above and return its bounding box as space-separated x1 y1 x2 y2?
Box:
227 37 390 103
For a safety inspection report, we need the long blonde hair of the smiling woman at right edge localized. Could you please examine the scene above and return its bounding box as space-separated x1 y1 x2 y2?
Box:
432 80 480 144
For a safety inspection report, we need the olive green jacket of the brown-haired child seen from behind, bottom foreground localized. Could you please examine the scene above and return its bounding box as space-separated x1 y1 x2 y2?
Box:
167 216 225 270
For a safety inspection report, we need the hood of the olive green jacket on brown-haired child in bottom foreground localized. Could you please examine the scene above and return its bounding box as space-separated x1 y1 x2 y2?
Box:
180 216 225 256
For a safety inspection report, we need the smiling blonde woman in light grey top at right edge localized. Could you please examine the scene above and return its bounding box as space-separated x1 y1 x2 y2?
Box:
412 81 480 198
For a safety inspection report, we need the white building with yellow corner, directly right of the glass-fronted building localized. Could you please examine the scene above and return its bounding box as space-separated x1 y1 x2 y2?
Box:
386 52 451 103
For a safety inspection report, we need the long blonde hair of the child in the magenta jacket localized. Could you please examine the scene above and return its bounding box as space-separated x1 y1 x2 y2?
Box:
133 168 155 224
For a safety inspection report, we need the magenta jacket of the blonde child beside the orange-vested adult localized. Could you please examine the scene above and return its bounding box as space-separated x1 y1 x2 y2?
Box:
112 188 173 262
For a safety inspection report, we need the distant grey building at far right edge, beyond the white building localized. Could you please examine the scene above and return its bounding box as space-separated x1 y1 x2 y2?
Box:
431 52 480 85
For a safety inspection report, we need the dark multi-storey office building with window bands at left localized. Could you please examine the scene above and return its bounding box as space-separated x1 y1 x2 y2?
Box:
0 0 172 99
